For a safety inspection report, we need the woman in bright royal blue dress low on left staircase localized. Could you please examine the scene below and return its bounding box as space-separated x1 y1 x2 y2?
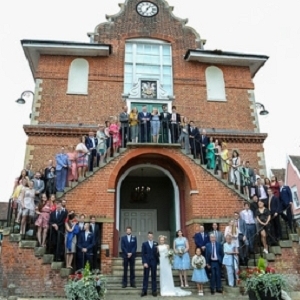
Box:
65 212 80 269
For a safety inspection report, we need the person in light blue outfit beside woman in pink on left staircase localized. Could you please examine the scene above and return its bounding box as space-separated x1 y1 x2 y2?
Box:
55 147 69 192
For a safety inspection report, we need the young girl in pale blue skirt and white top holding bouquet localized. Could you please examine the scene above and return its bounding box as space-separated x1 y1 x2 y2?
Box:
192 248 208 296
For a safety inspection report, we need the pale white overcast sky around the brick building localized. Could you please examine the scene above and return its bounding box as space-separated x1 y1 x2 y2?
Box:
0 0 300 201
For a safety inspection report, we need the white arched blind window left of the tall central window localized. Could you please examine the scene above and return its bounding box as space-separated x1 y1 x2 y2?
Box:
67 58 89 95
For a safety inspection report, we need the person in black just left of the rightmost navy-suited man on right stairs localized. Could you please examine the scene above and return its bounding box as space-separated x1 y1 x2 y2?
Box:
268 188 282 242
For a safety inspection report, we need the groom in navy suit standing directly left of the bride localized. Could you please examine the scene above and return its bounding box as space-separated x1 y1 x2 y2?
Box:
141 231 159 297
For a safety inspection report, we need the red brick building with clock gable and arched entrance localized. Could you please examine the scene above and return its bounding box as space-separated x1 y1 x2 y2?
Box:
1 0 280 296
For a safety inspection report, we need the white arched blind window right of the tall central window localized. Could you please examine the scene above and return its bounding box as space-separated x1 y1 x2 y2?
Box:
205 66 226 101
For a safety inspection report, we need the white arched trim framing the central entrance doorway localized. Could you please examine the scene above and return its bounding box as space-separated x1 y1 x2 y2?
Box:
116 164 181 230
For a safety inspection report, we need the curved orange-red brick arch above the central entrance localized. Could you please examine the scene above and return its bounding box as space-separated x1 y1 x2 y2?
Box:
108 148 197 190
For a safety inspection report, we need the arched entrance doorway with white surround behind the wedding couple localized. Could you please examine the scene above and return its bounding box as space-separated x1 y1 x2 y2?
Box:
116 164 181 252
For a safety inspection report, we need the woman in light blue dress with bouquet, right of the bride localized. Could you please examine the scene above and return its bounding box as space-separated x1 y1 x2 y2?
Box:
173 230 191 287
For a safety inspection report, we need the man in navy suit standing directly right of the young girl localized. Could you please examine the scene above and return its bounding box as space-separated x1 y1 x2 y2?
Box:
205 234 224 295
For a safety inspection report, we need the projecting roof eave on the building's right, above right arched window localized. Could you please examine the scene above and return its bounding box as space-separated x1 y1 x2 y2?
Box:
184 49 269 78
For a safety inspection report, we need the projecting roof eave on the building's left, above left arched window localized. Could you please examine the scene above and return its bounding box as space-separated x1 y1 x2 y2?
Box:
21 40 112 76
